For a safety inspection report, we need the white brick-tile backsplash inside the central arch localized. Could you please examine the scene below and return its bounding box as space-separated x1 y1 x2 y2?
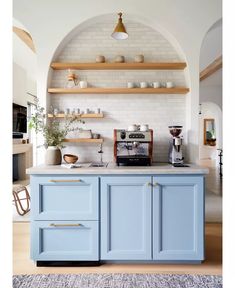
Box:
48 14 189 162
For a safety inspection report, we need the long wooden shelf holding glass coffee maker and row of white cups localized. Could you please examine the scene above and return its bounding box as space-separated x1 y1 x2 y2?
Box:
48 87 189 94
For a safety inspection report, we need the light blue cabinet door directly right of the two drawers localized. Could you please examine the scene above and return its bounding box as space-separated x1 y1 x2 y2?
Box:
101 176 152 260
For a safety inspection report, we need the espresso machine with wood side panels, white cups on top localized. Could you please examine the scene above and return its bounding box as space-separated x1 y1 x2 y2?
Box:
114 129 153 166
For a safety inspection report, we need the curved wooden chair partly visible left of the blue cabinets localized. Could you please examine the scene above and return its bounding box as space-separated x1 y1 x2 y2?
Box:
12 184 30 216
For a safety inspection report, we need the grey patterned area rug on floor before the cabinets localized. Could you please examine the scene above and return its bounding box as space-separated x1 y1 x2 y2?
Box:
13 274 222 288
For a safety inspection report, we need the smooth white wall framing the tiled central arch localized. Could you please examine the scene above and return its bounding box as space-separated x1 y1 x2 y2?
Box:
13 0 221 161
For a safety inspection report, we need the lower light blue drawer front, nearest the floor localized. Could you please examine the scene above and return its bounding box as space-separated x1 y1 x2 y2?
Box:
31 221 99 261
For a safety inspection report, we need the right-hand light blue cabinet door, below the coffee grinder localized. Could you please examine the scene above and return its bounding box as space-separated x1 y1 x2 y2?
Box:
153 176 204 260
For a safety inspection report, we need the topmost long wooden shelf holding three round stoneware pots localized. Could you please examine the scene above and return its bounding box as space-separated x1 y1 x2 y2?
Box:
51 62 187 70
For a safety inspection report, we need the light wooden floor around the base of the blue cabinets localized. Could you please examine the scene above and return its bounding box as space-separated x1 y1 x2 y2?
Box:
13 222 222 275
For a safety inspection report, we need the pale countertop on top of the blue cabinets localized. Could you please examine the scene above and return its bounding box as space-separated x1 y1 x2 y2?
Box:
26 162 209 175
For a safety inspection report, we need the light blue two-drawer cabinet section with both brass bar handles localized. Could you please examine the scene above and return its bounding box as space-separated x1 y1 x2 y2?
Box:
30 175 99 261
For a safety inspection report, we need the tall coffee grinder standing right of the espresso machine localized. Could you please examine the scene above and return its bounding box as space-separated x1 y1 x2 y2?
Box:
168 126 185 167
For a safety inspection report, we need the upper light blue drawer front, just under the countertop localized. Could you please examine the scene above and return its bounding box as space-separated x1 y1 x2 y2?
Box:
31 175 99 220
